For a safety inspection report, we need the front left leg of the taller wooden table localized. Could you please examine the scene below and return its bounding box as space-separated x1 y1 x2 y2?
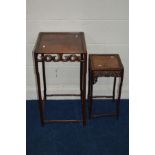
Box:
34 54 44 126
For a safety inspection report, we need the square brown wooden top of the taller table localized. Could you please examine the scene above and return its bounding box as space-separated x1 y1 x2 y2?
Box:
34 32 87 54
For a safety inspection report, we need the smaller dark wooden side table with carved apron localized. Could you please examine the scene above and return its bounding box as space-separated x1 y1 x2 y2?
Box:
88 54 124 119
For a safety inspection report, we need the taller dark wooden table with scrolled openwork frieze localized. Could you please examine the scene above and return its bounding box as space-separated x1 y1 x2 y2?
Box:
33 32 87 126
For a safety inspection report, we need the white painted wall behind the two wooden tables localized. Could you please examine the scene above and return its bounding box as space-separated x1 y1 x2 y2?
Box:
26 0 129 99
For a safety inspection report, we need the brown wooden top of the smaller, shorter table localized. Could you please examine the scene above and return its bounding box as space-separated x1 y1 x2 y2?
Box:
90 54 123 71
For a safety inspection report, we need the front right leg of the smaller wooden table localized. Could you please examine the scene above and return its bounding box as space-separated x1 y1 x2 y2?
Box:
116 73 124 119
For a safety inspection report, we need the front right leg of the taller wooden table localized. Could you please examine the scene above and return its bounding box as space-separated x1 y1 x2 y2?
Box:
82 54 87 126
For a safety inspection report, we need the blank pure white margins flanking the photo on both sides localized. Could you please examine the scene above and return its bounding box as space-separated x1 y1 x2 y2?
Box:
0 0 155 155
